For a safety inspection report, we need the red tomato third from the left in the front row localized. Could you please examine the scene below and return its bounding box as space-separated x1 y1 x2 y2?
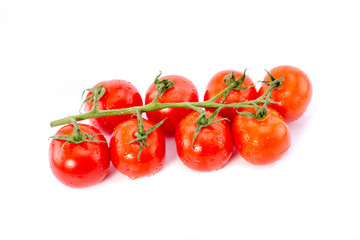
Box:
175 112 233 172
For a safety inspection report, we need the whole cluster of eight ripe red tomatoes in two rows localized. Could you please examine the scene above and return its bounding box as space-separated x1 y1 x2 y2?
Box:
50 66 312 187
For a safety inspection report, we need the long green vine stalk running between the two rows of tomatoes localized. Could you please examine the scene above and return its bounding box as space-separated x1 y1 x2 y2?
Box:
50 72 283 127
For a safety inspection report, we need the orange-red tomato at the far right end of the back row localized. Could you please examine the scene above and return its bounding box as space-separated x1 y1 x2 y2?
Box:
259 66 312 122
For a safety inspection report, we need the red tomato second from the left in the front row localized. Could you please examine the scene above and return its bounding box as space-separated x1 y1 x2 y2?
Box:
110 119 165 179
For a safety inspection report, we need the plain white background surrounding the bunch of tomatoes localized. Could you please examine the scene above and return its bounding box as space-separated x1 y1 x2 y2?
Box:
0 0 360 240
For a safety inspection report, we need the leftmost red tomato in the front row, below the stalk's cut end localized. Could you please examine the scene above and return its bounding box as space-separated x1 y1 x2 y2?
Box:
49 124 110 188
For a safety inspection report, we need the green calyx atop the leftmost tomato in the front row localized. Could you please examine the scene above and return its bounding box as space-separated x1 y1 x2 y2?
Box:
50 120 107 150
